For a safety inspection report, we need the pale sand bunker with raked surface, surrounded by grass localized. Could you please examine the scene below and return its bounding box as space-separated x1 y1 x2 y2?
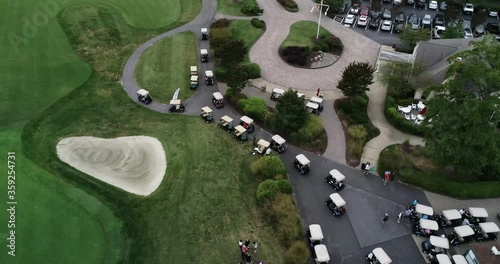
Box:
56 136 167 196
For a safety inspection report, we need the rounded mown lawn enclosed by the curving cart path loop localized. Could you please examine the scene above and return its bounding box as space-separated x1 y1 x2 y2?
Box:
135 32 197 103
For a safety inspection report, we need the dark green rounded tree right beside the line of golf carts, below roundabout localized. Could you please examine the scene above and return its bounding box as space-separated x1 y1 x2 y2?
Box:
273 90 309 134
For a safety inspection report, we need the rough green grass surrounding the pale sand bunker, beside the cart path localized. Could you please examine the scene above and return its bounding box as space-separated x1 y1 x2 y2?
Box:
23 2 283 263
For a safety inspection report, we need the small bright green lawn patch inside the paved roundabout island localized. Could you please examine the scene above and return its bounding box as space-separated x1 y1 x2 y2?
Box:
281 21 332 48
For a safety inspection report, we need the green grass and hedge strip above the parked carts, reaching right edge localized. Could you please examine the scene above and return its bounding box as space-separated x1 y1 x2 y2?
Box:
378 144 500 199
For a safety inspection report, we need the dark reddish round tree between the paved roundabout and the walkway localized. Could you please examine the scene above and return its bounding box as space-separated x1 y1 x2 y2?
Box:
337 62 375 99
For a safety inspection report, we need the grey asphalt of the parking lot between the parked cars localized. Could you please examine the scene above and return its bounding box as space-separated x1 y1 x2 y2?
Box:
333 0 499 46
